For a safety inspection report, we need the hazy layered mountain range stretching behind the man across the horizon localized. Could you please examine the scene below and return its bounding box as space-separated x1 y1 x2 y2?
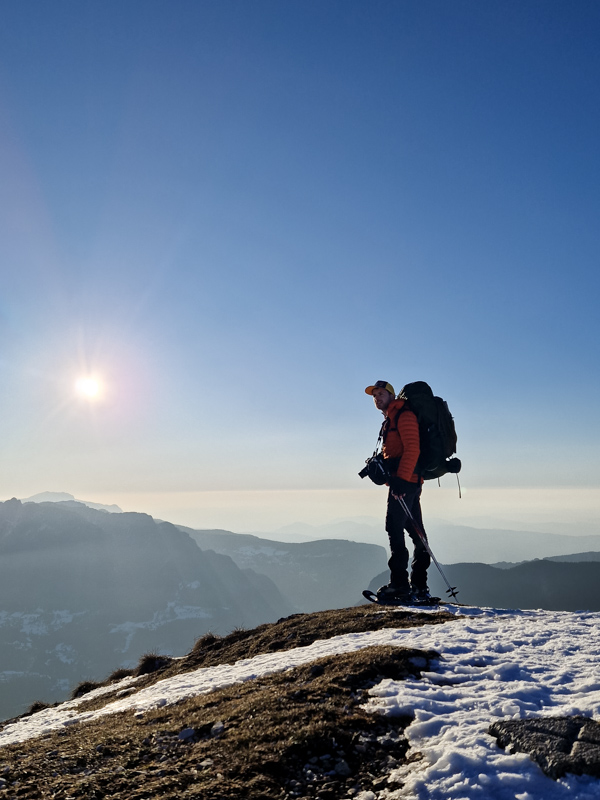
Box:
7 493 600 717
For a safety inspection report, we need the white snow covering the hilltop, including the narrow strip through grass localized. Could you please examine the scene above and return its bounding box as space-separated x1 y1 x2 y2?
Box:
0 607 600 800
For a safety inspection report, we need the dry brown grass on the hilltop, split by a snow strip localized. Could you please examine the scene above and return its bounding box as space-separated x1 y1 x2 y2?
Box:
0 606 449 800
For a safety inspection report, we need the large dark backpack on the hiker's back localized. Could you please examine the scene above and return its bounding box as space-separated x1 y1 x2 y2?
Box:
395 381 462 481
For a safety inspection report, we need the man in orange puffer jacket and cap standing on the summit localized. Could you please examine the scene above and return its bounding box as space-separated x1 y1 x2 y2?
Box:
365 381 431 603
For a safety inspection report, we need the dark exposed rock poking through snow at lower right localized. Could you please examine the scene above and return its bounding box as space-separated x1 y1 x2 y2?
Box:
488 717 600 780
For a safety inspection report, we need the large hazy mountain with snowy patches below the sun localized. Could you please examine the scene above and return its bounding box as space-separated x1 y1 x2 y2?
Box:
0 499 293 717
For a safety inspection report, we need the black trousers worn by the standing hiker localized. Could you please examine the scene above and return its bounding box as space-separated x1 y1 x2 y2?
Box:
385 484 431 591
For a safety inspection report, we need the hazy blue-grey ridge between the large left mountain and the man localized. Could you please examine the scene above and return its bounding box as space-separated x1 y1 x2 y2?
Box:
182 528 387 612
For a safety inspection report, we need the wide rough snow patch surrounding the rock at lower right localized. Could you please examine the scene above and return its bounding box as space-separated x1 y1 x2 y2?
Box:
366 611 600 800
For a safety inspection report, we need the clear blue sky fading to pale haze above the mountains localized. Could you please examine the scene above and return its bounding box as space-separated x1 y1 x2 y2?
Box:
0 0 600 530
